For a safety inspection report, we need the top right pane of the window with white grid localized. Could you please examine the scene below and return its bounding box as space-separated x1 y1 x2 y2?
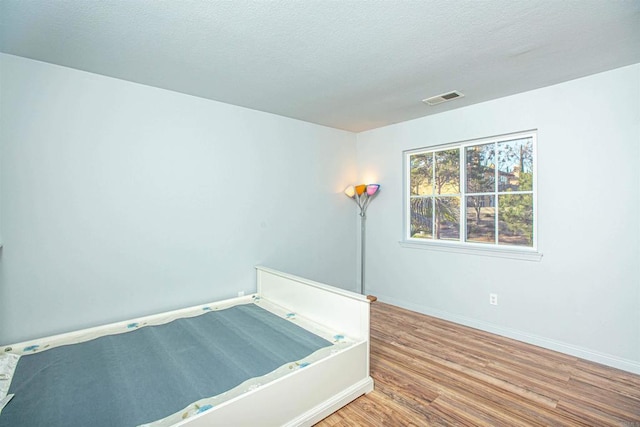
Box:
498 138 533 191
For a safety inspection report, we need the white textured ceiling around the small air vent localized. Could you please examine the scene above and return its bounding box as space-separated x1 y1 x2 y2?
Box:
0 0 640 132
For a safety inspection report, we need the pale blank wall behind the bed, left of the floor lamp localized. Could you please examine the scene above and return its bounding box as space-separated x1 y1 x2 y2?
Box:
0 55 356 344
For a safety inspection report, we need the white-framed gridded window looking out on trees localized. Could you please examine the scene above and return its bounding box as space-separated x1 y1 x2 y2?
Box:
405 132 537 260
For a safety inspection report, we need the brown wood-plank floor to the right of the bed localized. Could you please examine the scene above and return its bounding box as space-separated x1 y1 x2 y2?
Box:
316 302 640 427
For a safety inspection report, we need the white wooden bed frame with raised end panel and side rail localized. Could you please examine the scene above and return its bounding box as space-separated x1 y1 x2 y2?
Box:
0 267 373 427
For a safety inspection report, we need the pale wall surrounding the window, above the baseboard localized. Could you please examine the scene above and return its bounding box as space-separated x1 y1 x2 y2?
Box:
358 64 640 373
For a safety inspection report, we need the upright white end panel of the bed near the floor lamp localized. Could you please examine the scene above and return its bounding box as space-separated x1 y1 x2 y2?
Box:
256 267 370 340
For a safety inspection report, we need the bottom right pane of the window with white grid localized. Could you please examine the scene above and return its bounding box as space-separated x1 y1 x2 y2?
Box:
498 194 533 246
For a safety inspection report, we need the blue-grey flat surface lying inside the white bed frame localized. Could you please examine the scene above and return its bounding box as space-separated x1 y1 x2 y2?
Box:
0 304 331 427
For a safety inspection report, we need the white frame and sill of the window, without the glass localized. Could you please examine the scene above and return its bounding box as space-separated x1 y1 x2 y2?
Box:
400 130 542 261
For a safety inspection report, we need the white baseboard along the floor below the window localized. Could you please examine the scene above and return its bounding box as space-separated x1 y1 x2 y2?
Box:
376 294 640 375
